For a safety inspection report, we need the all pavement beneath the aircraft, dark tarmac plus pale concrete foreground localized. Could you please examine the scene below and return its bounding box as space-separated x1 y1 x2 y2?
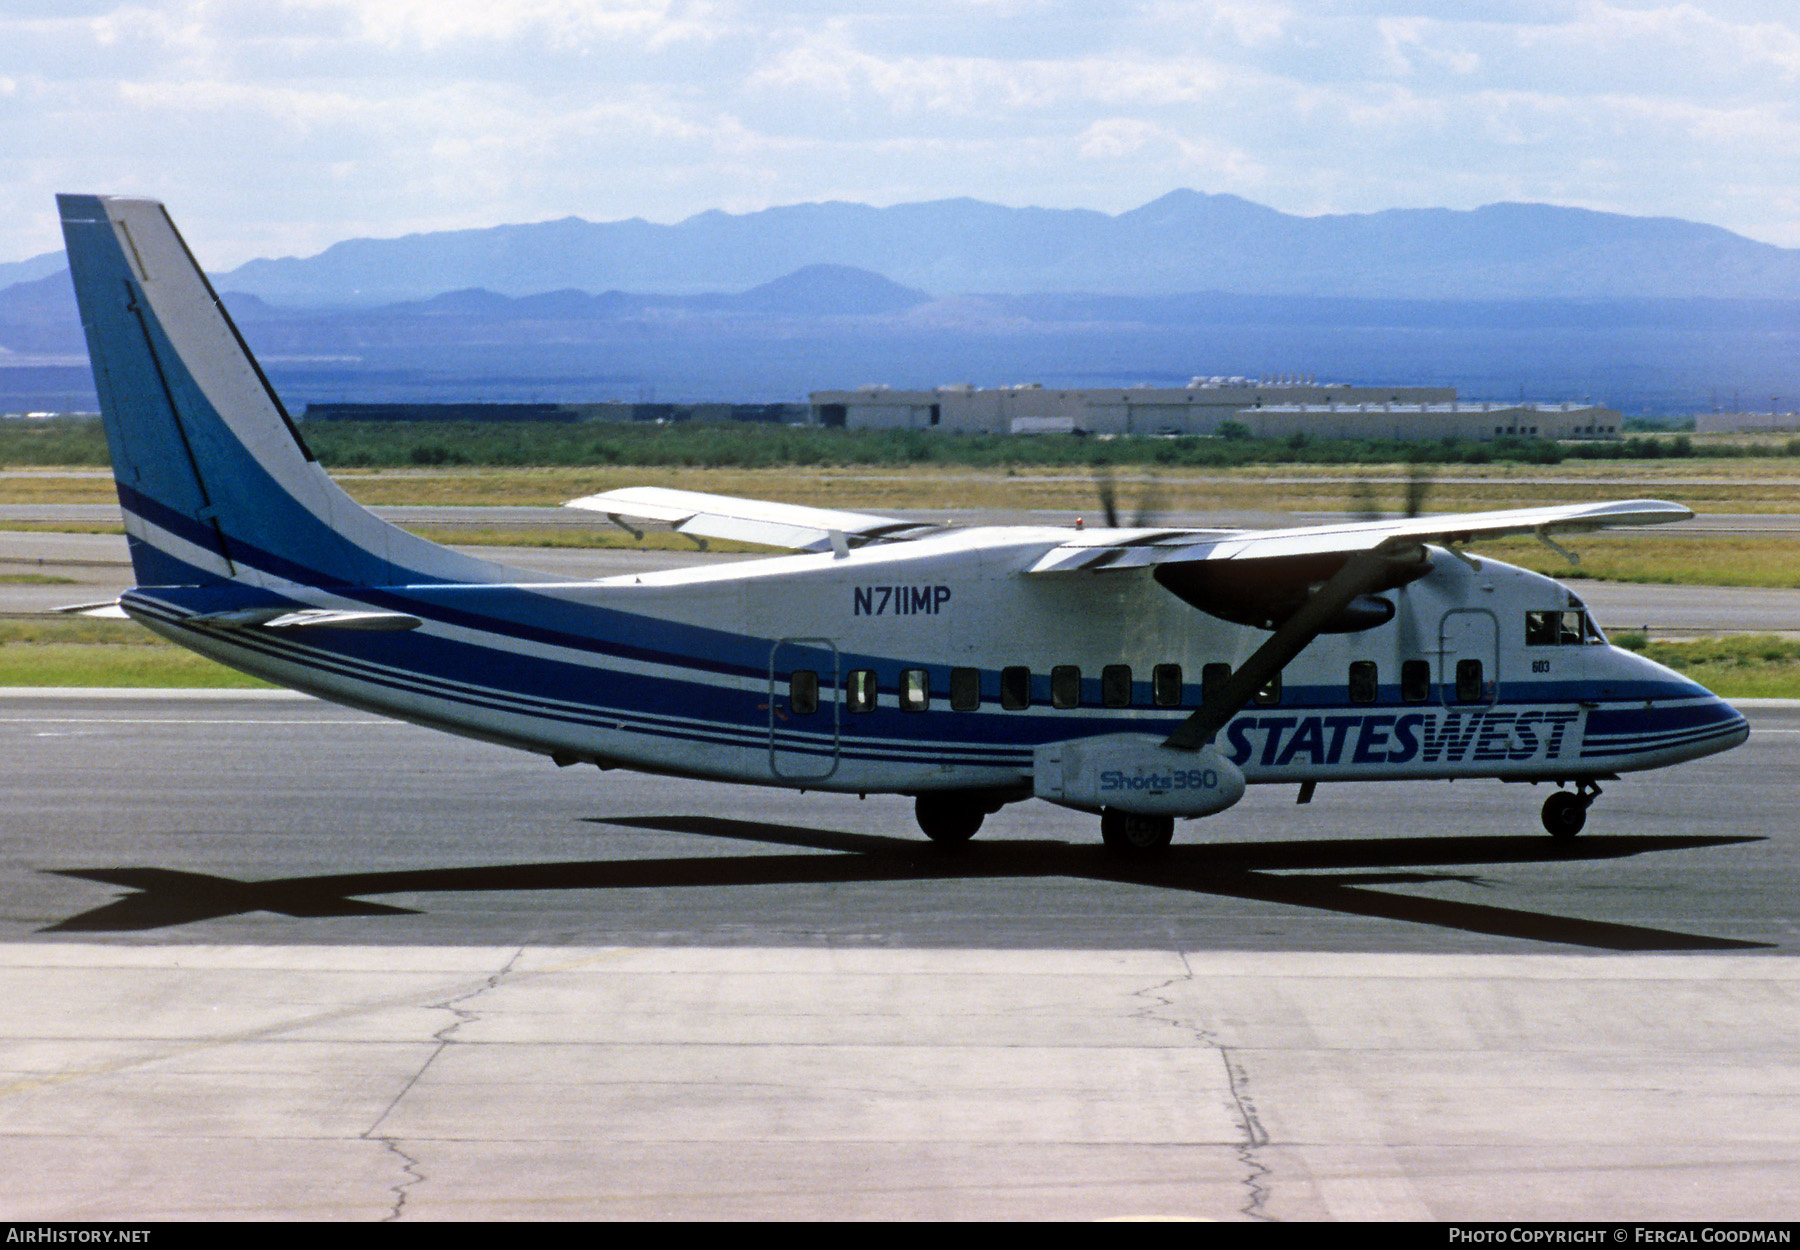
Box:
0 692 1800 1221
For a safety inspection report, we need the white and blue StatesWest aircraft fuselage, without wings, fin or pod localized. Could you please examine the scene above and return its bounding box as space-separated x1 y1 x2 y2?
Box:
116 528 1742 793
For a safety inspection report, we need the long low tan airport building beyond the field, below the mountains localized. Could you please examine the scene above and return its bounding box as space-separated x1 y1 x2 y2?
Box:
812 378 1620 439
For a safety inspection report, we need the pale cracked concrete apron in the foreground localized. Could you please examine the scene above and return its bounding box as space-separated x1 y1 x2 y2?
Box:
0 944 1800 1221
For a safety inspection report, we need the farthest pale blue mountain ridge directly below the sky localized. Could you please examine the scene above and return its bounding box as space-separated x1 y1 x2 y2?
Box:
204 191 1800 304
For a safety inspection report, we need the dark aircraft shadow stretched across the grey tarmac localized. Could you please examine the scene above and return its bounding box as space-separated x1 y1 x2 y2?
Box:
40 816 1769 951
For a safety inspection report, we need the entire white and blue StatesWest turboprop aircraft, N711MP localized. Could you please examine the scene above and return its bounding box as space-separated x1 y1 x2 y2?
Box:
59 196 1748 850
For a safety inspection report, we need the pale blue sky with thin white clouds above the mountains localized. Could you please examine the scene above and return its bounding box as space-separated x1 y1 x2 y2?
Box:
0 0 1800 268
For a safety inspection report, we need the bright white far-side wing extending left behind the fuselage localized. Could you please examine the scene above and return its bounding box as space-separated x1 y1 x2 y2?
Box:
565 486 941 553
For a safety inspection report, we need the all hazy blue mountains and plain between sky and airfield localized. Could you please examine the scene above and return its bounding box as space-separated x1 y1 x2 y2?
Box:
0 191 1800 412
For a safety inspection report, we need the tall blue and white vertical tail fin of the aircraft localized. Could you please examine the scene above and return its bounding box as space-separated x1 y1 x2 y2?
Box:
56 195 535 587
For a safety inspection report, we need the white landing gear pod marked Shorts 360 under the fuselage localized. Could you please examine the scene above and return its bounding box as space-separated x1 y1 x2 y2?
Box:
1031 733 1244 816
